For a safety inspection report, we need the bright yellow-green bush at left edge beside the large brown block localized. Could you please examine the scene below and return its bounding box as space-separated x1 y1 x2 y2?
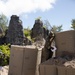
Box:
0 44 10 66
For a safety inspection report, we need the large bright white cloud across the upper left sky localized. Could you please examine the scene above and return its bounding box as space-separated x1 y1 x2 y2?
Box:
0 0 56 16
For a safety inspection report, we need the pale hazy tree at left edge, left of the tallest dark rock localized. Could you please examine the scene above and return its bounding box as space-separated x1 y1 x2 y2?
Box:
0 14 8 32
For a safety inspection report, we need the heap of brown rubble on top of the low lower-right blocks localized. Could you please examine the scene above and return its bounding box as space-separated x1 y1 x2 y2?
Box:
48 56 75 69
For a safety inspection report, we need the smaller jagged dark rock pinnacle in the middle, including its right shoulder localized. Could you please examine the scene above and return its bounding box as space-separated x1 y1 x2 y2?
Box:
31 19 49 40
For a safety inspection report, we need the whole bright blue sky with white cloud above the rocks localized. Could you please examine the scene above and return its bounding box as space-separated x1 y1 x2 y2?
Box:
0 0 75 31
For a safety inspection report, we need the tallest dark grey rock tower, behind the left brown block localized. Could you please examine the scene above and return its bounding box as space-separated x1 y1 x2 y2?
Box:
6 15 24 45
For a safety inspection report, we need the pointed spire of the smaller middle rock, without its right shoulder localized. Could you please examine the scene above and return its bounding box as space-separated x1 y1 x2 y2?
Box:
31 19 44 39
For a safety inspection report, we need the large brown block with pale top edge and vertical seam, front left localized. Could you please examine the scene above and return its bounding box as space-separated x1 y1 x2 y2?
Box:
9 45 41 75
